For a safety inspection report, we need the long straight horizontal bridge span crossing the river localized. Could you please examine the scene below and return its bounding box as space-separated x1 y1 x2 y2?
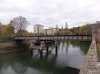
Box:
14 35 92 41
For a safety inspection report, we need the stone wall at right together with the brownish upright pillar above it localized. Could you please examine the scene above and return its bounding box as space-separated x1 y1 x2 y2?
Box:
79 24 100 74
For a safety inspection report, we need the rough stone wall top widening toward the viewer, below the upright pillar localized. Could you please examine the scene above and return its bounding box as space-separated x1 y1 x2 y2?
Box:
80 39 100 74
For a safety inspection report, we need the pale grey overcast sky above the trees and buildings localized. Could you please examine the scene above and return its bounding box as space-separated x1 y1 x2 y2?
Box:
0 0 100 31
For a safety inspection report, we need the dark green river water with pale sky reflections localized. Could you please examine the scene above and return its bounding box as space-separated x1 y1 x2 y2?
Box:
0 41 90 74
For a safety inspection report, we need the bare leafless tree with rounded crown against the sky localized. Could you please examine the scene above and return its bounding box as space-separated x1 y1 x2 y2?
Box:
10 16 29 31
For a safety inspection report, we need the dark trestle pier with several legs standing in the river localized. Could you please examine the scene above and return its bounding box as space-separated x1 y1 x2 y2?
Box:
30 41 58 58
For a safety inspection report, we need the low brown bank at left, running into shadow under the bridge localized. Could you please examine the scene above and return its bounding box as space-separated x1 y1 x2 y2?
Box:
0 43 29 53
